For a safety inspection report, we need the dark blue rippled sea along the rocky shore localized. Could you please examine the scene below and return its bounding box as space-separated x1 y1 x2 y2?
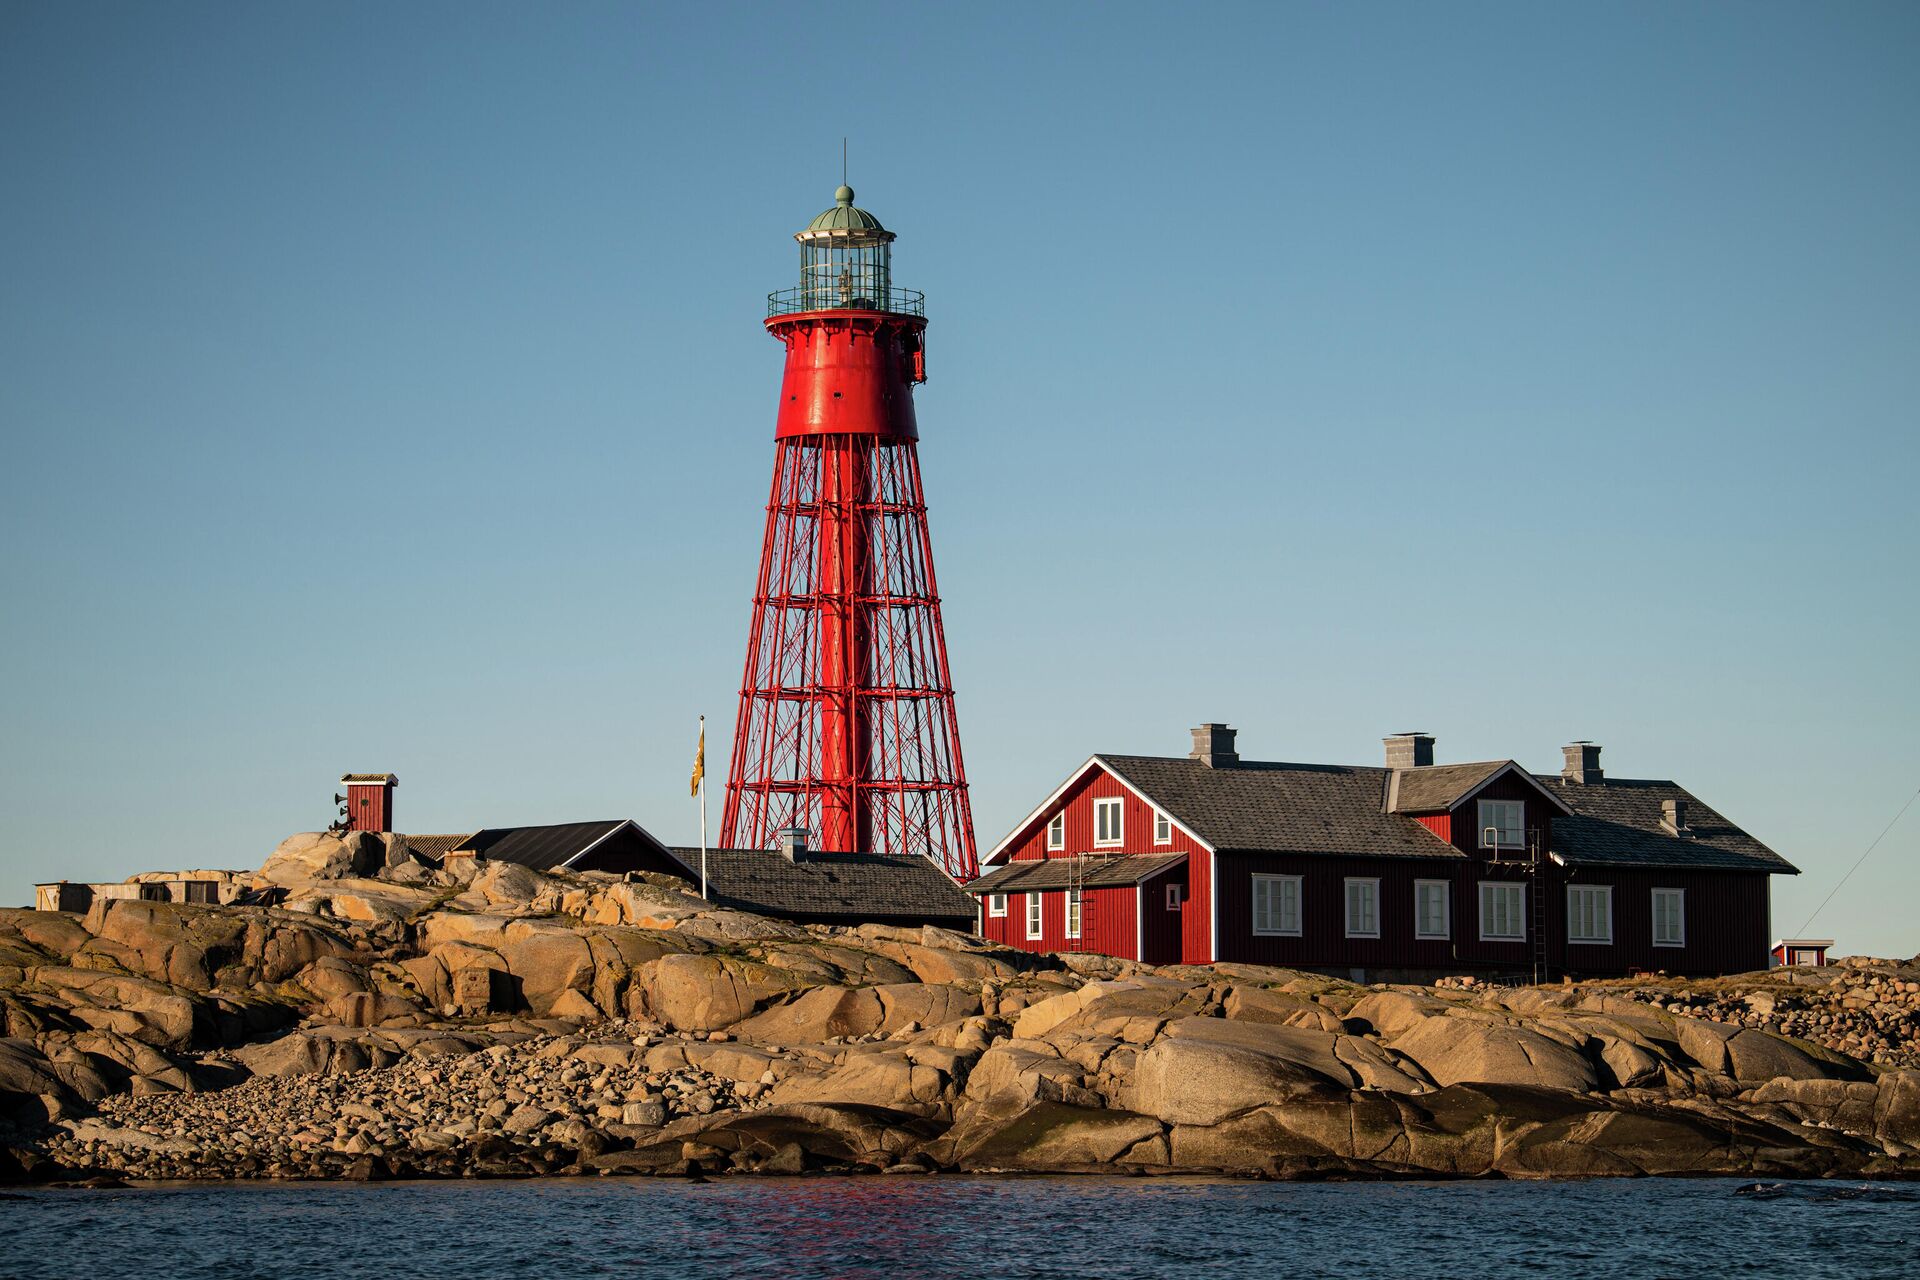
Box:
0 1176 1920 1280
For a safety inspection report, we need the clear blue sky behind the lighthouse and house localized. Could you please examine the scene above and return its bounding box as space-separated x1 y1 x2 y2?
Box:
0 0 1920 956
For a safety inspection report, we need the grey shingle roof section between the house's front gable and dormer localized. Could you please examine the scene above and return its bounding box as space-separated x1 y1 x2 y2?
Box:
1100 756 1465 858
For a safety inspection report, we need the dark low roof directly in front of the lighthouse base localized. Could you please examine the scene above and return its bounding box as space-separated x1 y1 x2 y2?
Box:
672 846 973 925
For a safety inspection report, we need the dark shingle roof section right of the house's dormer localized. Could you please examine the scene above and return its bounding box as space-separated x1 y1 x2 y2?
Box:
1538 773 1799 875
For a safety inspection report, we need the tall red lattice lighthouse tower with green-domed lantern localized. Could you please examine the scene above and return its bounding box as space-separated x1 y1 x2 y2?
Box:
720 186 979 881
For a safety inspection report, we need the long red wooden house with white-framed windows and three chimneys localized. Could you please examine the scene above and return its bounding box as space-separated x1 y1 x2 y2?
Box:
966 725 1797 981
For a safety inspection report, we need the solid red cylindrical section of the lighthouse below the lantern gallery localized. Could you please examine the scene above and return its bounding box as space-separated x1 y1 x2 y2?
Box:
766 311 927 439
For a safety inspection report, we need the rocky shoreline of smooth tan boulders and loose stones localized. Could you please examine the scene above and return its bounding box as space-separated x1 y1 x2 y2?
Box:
0 837 1920 1182
